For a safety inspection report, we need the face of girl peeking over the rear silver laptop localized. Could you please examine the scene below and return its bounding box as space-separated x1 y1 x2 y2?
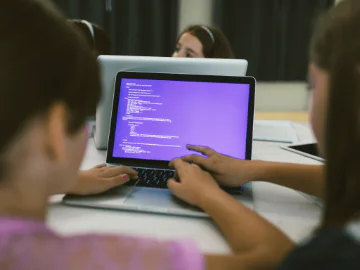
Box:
172 33 205 58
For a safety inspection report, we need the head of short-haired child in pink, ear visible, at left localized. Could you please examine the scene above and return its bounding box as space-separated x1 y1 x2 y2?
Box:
0 0 100 192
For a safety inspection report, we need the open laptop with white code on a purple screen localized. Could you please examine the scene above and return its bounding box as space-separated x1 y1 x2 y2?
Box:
63 72 255 217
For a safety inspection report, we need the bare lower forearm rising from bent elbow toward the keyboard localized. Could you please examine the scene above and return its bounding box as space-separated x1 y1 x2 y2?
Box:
200 189 293 255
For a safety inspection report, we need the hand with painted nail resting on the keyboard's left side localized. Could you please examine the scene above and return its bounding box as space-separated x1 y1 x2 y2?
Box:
68 164 138 195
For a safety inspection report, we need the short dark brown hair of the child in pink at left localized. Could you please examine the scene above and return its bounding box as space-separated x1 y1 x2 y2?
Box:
0 0 100 177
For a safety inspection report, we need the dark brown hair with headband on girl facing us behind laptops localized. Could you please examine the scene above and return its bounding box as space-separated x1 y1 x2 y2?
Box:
177 25 235 58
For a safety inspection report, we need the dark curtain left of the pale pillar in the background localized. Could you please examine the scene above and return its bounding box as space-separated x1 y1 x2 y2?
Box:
53 0 178 56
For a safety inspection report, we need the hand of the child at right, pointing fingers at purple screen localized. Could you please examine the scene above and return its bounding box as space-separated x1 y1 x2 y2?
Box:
182 145 259 187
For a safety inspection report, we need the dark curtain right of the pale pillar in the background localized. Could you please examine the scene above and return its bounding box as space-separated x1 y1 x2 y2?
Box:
214 0 334 81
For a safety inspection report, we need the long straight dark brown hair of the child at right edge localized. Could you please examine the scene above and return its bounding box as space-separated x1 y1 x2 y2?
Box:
310 0 360 228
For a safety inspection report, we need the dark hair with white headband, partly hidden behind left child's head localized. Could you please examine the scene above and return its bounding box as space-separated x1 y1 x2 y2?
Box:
70 20 111 56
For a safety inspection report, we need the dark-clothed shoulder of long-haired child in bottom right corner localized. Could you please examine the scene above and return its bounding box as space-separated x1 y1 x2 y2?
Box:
278 228 360 270
